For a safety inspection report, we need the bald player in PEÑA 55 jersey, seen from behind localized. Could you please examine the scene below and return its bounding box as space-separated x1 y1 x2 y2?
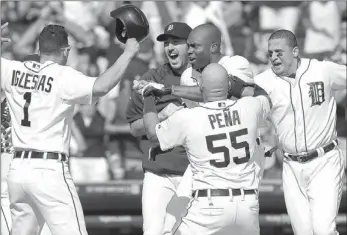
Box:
143 63 271 235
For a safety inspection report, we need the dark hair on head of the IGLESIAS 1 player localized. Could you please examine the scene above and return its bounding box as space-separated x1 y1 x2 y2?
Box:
39 24 69 54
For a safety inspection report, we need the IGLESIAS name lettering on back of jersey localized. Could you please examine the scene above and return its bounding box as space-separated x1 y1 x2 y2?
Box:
11 70 54 93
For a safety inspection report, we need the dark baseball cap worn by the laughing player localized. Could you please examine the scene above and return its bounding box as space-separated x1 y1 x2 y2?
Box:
157 22 192 42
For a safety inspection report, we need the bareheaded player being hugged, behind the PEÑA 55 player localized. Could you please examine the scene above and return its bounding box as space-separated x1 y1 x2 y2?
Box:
132 24 265 233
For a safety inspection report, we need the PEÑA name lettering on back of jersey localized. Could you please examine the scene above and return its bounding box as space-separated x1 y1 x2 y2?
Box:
208 110 241 129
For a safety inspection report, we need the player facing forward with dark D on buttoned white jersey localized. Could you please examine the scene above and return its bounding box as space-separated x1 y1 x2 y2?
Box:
255 30 346 235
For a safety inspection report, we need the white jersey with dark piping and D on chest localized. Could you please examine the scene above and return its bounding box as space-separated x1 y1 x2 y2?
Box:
254 59 346 154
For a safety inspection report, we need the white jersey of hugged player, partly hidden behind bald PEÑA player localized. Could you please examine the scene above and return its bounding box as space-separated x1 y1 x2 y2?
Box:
181 55 254 108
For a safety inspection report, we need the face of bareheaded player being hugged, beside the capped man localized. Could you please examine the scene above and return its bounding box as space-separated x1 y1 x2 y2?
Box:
187 32 211 69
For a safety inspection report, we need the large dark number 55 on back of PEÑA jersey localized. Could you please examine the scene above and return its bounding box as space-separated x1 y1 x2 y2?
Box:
206 128 250 168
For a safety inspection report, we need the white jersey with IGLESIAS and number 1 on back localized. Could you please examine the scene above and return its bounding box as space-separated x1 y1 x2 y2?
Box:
1 58 96 154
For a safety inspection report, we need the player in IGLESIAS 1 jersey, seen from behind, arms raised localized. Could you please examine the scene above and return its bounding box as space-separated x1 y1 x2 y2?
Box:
1 24 139 235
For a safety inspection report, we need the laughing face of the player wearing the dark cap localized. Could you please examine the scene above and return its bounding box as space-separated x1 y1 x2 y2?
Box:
164 38 188 70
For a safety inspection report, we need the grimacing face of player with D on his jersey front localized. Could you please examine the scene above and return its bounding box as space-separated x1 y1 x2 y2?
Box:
268 38 297 76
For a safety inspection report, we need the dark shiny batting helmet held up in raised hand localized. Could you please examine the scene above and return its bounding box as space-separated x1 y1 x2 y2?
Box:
110 4 149 43
